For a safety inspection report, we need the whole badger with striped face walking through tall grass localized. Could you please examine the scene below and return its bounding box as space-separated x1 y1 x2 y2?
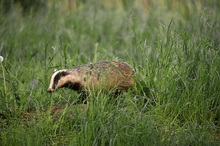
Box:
48 61 135 92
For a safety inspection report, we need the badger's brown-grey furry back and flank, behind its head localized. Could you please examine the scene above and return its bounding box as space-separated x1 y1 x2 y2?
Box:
67 61 134 90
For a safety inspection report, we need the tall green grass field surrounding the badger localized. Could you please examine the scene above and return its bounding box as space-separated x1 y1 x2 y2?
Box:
0 1 220 146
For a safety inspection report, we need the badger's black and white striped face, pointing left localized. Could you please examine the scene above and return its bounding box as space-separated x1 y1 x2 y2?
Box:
47 69 66 93
